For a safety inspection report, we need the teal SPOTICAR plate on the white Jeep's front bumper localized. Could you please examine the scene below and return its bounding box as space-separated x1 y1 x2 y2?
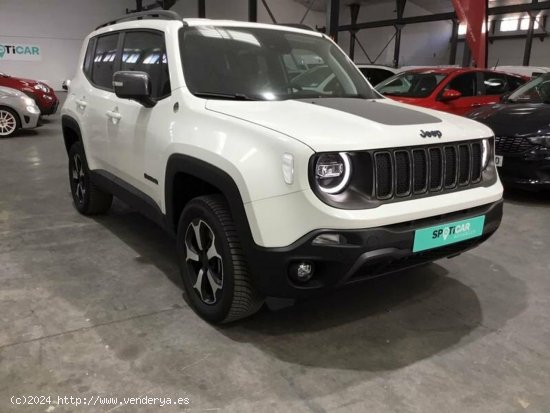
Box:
413 215 485 252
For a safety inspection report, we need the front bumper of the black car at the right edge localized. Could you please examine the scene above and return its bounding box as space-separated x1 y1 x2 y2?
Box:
498 148 550 190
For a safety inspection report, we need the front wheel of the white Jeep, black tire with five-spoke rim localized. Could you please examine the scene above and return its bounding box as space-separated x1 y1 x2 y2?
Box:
177 195 264 323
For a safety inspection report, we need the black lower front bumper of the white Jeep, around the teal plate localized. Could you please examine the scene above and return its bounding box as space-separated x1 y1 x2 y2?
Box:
247 200 503 298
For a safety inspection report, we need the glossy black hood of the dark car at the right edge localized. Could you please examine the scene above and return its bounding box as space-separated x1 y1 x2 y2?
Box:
468 103 550 137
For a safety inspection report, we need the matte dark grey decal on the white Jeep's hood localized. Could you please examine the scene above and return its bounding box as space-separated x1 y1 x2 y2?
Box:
299 98 442 126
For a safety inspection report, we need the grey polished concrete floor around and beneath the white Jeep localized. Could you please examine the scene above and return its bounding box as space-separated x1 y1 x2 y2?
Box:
0 98 550 413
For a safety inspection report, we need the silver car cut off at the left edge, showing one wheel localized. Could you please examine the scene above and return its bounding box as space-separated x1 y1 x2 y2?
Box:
0 86 40 138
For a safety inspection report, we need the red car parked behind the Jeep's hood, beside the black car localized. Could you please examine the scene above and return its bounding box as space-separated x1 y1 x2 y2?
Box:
376 67 529 115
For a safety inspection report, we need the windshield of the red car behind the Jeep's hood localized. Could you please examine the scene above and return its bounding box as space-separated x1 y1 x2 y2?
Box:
376 72 446 98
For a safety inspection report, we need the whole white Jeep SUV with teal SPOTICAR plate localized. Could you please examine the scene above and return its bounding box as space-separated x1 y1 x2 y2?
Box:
62 12 502 322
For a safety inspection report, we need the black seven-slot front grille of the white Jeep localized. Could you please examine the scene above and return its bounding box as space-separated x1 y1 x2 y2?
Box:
374 141 482 199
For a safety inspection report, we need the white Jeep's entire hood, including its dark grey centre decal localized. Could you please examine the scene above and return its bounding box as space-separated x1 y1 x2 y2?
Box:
206 98 492 152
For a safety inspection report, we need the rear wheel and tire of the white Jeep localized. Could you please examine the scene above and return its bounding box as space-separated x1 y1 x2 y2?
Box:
69 142 113 215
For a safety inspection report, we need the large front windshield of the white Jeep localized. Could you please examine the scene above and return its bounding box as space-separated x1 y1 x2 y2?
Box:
180 26 380 100
